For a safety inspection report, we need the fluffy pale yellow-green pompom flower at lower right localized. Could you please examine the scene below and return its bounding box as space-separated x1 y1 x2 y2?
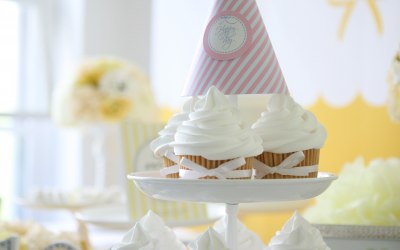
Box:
304 158 400 226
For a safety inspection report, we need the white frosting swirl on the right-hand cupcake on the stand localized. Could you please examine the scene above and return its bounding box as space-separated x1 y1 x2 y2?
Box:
251 94 326 153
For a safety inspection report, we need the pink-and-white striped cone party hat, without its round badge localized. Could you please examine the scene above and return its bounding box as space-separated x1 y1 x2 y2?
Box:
183 0 289 96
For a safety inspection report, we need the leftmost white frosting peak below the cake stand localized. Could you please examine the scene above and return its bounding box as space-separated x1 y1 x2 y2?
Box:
111 211 186 250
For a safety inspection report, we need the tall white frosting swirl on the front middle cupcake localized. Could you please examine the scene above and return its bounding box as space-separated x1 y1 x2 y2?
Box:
171 87 262 160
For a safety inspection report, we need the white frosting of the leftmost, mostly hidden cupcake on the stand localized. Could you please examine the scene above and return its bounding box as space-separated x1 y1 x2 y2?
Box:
150 97 197 157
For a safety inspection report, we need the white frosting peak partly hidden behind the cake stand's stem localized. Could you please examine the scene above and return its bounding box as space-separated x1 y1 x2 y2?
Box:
212 216 264 250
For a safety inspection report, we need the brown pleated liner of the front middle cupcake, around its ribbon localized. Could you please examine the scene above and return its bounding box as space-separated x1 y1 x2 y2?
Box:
178 155 253 180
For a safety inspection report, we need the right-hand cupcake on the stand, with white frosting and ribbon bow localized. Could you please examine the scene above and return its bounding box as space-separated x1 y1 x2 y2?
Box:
251 94 326 179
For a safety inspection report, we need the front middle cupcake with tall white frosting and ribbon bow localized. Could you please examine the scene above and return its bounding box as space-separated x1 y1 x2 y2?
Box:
171 87 262 179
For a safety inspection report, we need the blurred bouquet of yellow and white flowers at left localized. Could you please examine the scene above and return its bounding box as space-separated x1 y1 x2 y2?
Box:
53 58 158 126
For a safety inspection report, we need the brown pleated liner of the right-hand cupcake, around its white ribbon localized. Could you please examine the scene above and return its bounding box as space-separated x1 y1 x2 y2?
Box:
256 149 320 179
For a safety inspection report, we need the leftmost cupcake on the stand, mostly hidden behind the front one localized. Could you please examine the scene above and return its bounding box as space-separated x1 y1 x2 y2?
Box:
150 98 197 178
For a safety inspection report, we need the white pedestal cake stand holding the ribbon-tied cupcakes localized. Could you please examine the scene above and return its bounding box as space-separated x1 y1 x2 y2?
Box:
128 171 337 250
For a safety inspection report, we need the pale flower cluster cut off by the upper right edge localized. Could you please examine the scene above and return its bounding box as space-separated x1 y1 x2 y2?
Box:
387 49 400 122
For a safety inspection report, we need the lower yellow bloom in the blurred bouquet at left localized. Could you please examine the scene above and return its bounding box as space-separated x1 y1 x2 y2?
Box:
100 98 132 121
